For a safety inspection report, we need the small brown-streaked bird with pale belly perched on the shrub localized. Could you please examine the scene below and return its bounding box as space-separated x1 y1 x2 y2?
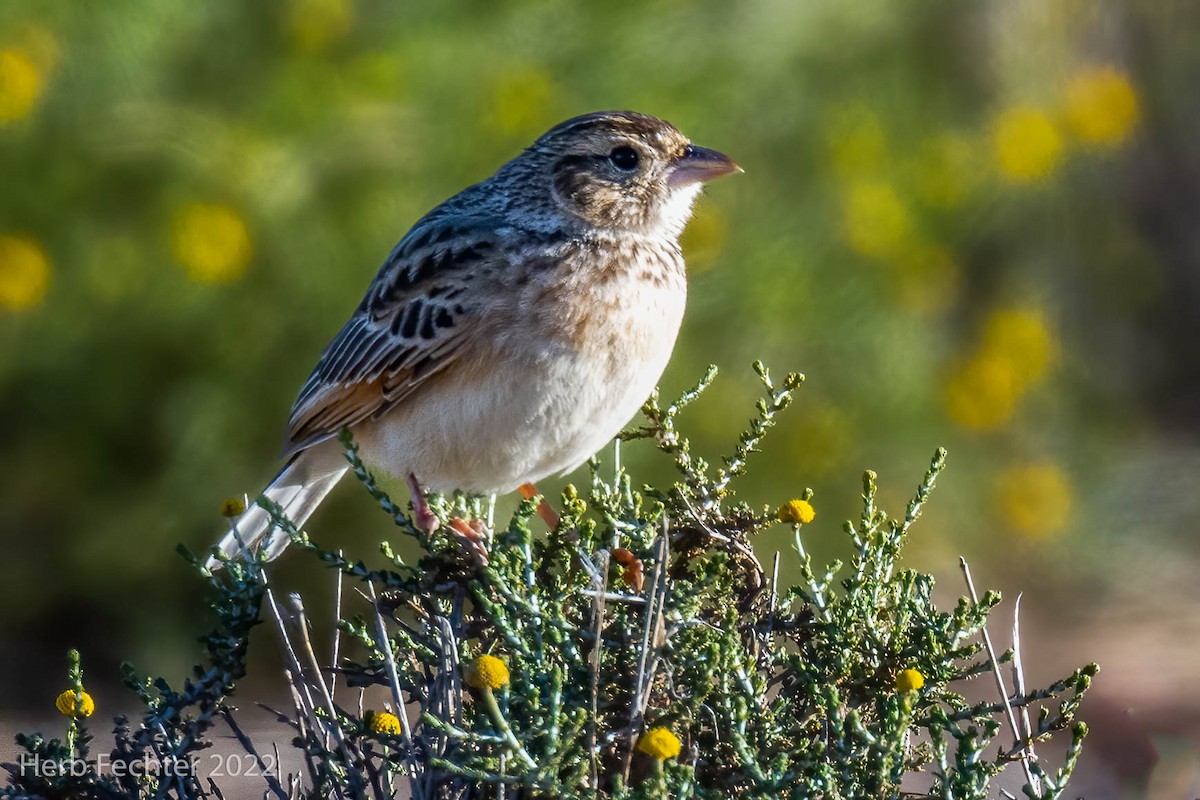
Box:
206 112 742 569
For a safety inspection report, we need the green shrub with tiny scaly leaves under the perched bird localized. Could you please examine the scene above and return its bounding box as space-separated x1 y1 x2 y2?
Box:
0 365 1097 800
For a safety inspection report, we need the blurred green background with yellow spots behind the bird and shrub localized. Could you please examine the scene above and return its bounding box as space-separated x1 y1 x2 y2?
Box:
0 0 1200 796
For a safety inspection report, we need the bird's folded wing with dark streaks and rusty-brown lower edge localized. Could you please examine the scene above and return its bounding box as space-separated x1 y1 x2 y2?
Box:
283 217 505 456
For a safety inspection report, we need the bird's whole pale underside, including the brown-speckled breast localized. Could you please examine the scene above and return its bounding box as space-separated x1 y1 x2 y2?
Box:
355 240 686 493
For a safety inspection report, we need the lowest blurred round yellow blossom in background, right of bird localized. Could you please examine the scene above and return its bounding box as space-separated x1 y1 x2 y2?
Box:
994 463 1074 539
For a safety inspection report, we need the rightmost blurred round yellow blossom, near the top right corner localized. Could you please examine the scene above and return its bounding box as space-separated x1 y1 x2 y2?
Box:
1063 66 1140 148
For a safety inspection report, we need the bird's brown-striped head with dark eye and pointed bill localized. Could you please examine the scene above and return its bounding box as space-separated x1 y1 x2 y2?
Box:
518 112 740 237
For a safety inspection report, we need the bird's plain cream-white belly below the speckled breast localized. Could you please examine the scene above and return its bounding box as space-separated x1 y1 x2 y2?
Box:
355 273 685 493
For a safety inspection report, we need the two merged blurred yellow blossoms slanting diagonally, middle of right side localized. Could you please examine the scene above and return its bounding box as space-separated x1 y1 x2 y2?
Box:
943 308 1058 431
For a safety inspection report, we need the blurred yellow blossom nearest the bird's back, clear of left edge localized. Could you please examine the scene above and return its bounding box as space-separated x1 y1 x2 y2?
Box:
174 203 252 283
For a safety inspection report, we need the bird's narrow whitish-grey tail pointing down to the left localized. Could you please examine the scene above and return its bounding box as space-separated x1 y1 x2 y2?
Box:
205 445 348 570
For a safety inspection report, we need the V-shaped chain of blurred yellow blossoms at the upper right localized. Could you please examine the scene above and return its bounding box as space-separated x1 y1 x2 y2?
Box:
826 66 1140 319
